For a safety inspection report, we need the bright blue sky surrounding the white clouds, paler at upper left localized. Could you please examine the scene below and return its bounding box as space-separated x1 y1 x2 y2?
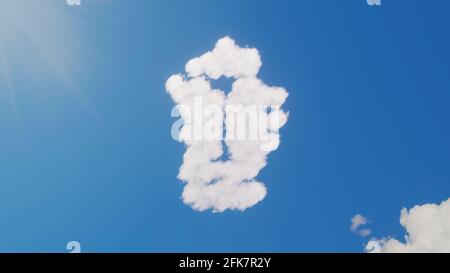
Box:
0 0 450 252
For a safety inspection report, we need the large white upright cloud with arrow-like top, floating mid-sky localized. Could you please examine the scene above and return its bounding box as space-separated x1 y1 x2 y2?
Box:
166 37 288 212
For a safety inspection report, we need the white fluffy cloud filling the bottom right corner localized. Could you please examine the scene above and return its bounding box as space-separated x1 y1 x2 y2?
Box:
367 199 450 253
